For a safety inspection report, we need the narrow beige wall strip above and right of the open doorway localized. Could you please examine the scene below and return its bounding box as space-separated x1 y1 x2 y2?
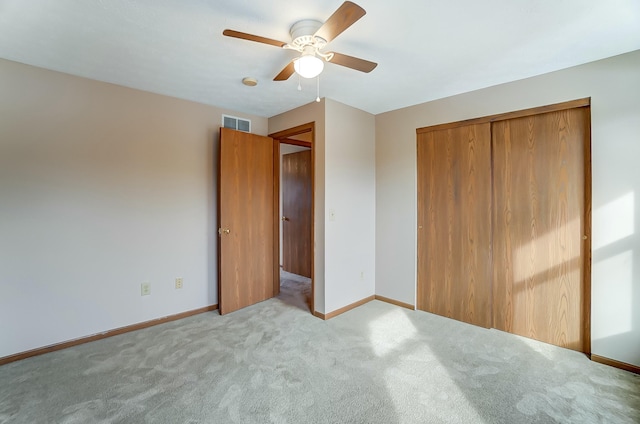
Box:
269 99 325 313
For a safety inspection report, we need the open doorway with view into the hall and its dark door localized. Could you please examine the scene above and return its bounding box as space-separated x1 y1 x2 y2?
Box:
270 123 315 313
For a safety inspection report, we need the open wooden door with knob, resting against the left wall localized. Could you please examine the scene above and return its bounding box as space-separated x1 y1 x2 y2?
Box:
218 128 275 314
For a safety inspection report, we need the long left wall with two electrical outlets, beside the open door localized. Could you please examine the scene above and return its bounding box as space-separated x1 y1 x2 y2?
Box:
0 60 267 357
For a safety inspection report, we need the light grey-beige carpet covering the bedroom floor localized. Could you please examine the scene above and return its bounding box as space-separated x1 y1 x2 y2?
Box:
0 276 640 424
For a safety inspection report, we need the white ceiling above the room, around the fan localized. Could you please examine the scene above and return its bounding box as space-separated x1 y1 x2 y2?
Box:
0 0 640 117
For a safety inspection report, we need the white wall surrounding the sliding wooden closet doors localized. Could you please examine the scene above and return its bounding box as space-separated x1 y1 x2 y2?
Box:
376 51 640 366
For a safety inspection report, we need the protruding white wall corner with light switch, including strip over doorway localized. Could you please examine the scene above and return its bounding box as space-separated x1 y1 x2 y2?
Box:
269 99 376 313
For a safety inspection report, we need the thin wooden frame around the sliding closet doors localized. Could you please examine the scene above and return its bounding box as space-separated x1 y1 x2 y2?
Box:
416 97 592 356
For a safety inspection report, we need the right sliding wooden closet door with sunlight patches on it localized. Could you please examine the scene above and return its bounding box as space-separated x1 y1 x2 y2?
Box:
492 107 590 351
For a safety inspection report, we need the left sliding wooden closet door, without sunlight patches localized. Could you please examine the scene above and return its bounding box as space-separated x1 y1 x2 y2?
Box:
417 123 491 327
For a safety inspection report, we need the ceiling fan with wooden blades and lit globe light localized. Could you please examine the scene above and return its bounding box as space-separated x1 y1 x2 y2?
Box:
222 1 378 81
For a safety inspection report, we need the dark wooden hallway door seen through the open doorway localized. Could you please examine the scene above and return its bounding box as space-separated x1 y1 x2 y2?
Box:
282 150 312 278
